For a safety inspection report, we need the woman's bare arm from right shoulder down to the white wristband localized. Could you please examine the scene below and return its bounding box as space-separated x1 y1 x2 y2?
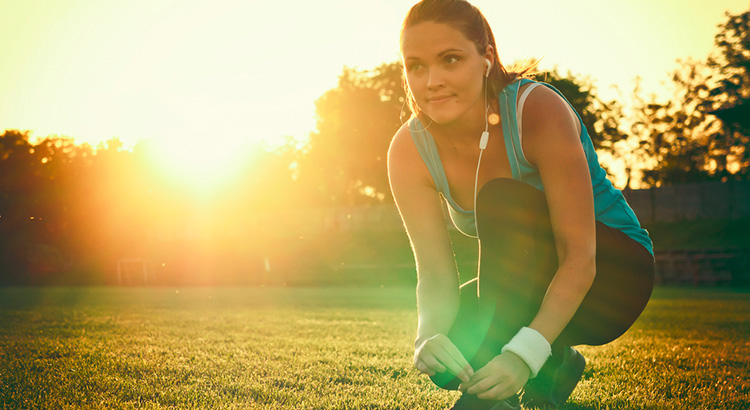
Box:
523 87 596 343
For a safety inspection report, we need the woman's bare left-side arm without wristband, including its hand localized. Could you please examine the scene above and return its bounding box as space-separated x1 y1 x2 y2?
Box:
388 127 473 379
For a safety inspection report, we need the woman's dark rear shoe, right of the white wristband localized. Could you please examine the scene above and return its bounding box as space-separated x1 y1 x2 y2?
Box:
521 347 586 408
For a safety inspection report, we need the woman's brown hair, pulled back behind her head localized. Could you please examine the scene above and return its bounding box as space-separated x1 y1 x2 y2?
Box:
401 0 538 115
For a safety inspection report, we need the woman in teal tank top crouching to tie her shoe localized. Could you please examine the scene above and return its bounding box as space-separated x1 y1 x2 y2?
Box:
388 0 654 409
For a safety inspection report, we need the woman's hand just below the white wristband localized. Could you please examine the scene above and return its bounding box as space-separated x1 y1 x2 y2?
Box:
458 352 531 400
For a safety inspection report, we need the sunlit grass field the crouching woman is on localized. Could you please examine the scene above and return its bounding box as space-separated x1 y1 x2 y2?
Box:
0 288 750 410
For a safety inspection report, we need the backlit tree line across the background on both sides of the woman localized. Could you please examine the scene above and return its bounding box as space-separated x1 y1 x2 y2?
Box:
0 11 750 284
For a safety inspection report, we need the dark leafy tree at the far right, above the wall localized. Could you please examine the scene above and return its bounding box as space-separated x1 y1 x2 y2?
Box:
633 12 750 186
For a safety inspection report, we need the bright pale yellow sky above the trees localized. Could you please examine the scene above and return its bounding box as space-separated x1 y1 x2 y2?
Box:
0 0 748 171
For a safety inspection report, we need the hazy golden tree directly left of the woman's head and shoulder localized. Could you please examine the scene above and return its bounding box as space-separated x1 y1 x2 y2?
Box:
299 63 405 205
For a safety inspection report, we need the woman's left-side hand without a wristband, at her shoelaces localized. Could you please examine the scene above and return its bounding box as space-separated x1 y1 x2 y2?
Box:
414 334 472 383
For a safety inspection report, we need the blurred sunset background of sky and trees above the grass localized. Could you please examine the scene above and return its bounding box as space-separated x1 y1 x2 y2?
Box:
0 0 750 286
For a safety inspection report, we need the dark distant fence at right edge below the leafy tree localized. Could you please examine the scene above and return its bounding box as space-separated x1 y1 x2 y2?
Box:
624 181 750 223
